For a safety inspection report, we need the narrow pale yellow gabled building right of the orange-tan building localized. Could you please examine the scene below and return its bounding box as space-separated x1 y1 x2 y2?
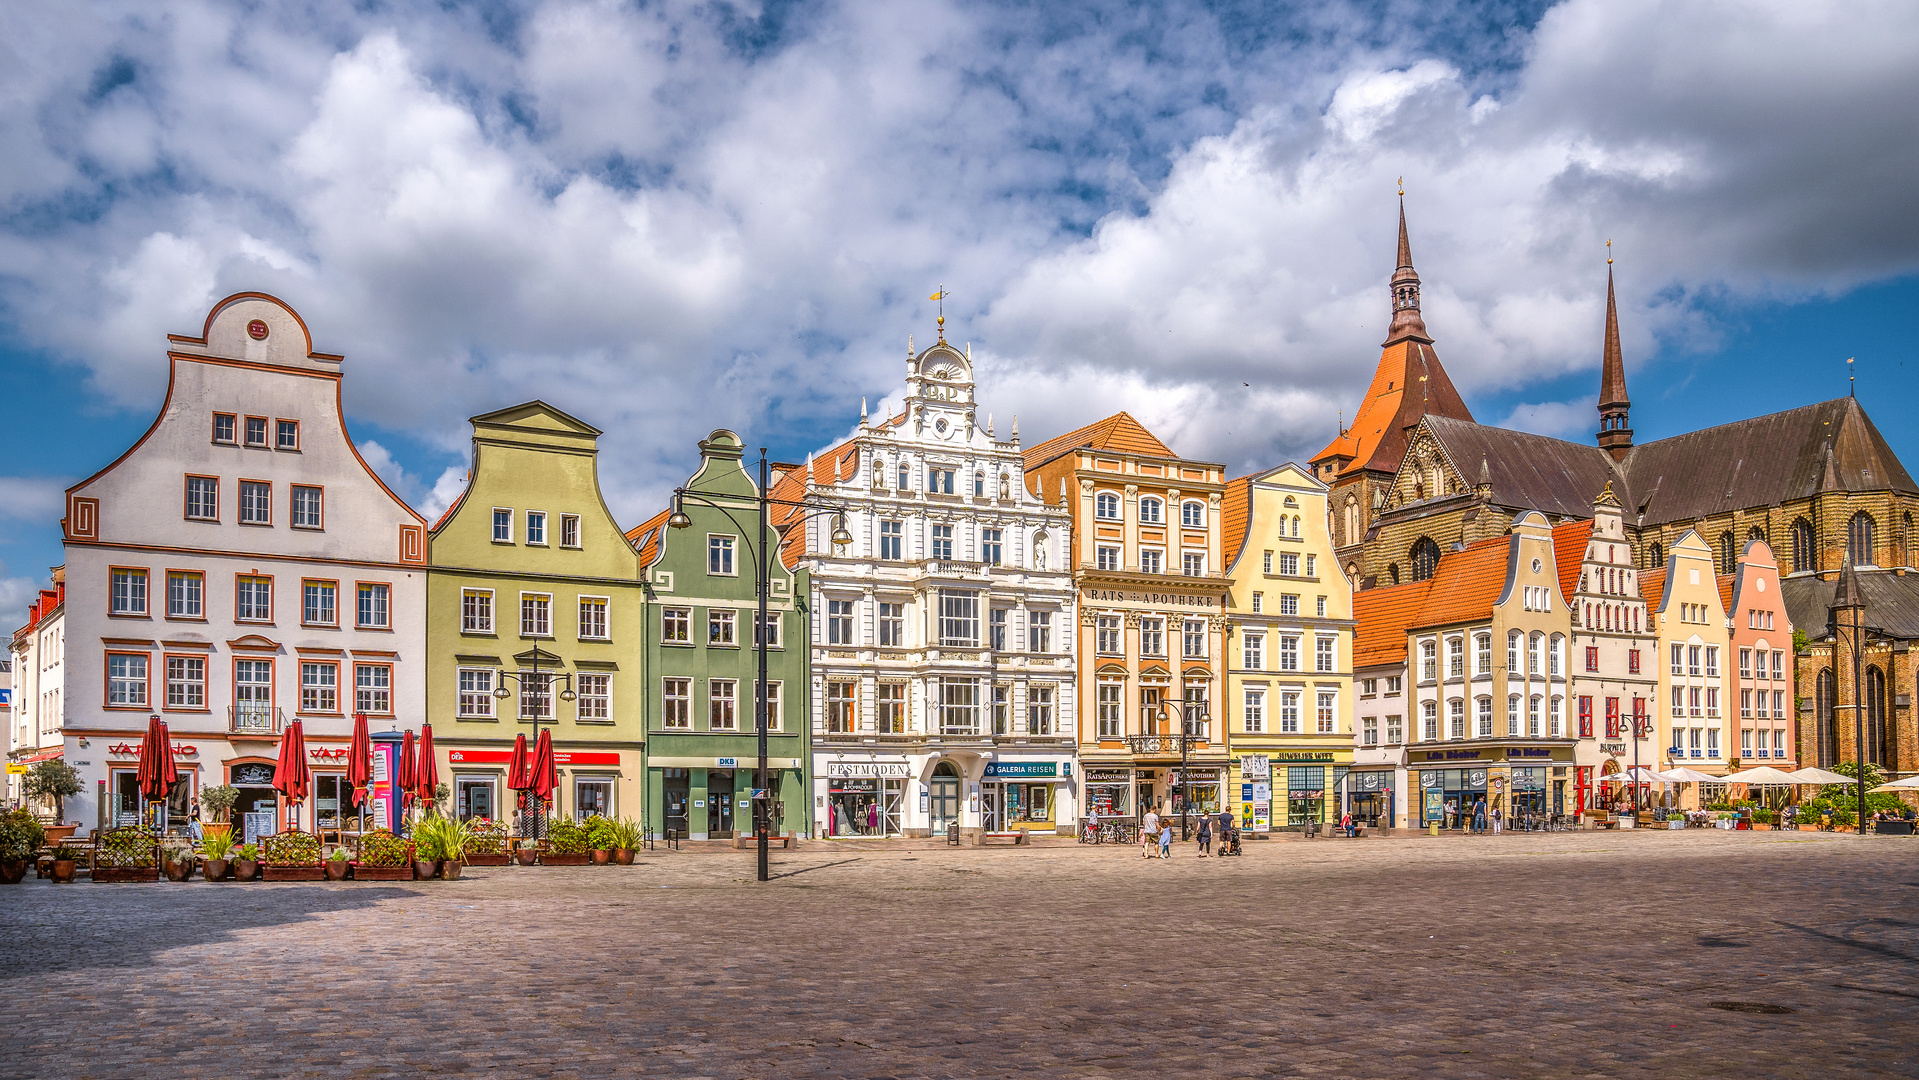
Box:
1220 464 1358 834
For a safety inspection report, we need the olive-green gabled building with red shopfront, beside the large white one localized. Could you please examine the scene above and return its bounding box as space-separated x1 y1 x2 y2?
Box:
426 401 647 821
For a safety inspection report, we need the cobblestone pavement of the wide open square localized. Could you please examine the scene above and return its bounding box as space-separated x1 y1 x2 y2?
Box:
0 831 1919 1080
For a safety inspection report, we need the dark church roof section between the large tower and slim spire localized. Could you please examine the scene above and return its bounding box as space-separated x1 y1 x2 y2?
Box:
1426 416 1629 518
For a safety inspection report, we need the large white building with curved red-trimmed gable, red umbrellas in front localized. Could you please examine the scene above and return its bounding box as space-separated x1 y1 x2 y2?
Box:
63 293 426 844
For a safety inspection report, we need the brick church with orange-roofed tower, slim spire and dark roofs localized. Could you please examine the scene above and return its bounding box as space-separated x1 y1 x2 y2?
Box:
1311 201 1919 773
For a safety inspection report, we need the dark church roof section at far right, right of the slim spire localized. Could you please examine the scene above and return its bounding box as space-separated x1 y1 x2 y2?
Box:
1622 397 1919 526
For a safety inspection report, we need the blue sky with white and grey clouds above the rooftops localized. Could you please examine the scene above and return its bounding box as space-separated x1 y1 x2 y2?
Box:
0 0 1919 618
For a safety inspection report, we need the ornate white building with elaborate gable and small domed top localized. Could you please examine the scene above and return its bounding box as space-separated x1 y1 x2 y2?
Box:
773 338 1077 836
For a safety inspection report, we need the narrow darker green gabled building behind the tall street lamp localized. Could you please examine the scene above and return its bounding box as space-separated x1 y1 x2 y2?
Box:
628 430 812 840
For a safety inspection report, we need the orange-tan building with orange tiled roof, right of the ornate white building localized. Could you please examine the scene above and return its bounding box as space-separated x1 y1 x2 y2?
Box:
1027 412 1230 817
